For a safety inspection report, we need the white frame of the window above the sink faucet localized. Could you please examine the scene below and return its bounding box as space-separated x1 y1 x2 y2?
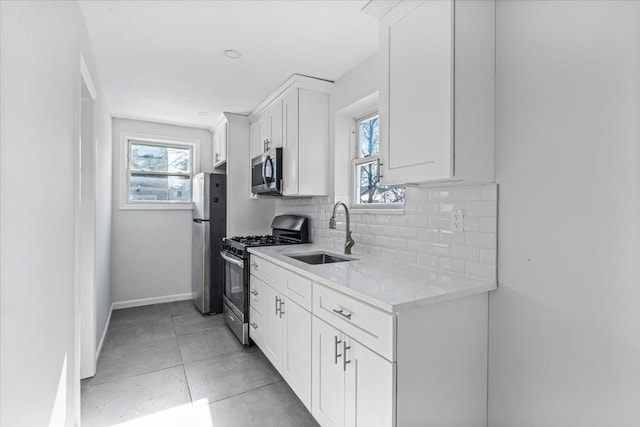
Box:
351 108 404 213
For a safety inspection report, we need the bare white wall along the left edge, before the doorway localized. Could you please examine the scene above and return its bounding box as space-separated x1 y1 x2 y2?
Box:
0 1 108 426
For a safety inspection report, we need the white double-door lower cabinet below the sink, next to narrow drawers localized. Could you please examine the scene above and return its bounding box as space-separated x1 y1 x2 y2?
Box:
249 274 311 410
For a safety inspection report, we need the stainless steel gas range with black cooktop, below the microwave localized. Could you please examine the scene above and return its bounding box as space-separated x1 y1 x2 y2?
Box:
220 215 309 345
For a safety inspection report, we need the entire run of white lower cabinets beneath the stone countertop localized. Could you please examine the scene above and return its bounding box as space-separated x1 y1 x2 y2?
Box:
249 254 488 427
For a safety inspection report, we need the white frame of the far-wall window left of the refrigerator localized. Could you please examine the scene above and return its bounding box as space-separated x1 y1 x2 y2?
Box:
119 132 200 210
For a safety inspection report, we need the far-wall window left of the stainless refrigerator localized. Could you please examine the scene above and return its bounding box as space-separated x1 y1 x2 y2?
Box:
121 137 195 209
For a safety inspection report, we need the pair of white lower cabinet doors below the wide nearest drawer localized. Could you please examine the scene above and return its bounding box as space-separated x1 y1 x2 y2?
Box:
312 316 395 427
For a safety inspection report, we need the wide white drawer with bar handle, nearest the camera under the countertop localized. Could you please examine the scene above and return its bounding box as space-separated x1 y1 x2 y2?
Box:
313 283 396 362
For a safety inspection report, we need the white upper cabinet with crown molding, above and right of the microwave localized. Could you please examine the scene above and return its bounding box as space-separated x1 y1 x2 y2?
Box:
249 74 333 197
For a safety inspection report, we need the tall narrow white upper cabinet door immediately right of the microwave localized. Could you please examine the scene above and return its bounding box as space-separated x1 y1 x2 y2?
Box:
282 89 299 195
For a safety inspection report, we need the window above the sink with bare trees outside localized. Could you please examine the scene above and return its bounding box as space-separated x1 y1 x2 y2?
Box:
353 113 405 208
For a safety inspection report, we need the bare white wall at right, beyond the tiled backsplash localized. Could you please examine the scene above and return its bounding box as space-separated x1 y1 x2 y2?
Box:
489 1 640 427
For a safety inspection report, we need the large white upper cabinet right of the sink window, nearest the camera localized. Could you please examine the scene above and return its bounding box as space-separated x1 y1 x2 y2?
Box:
379 0 495 185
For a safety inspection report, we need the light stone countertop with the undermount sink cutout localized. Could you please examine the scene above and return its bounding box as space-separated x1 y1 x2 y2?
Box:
249 244 497 313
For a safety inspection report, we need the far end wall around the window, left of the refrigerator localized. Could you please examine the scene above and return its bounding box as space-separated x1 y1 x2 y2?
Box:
111 118 213 303
